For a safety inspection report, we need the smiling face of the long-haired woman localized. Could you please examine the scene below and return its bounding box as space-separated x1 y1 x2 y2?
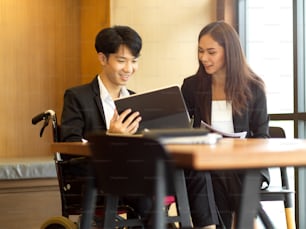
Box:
198 34 226 76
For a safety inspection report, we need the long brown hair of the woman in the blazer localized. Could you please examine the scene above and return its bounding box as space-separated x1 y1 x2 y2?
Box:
197 21 264 115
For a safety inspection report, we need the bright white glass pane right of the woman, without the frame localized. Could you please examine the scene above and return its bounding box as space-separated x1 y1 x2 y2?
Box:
239 0 294 137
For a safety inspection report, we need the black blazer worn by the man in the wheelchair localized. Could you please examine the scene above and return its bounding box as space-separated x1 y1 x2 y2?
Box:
61 76 134 142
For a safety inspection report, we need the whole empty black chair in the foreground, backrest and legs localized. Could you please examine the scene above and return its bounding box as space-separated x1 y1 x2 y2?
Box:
88 133 191 229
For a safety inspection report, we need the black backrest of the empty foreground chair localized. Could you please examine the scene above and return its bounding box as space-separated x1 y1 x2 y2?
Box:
88 133 174 196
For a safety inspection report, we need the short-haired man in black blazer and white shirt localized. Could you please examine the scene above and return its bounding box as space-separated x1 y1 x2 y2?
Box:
61 26 142 141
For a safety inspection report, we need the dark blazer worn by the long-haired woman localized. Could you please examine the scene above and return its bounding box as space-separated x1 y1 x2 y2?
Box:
182 75 269 183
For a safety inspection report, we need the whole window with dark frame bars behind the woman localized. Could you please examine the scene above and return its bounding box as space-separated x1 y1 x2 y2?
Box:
238 0 306 228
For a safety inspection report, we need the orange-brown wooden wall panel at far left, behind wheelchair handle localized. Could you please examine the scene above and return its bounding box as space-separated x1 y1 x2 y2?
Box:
0 0 81 157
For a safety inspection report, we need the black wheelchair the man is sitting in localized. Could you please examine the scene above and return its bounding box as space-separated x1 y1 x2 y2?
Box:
32 110 139 229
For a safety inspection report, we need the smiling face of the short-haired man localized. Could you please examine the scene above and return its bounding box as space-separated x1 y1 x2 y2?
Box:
98 45 138 87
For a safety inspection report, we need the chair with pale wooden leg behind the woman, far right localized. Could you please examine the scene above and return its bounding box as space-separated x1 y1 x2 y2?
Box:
258 127 295 229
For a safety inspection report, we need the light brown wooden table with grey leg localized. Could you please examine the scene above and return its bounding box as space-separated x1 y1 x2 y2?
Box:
51 138 306 229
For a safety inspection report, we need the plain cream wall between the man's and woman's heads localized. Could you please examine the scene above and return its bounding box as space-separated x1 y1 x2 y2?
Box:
111 0 216 92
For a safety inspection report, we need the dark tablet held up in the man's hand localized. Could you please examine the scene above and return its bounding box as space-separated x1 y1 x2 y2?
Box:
114 86 190 131
